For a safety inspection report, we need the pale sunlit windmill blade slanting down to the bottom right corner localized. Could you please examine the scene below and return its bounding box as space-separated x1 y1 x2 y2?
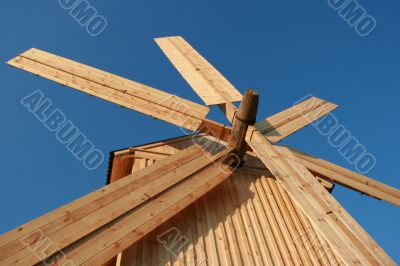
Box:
246 127 395 265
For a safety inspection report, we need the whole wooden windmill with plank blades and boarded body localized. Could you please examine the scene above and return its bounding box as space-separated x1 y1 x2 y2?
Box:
0 37 400 265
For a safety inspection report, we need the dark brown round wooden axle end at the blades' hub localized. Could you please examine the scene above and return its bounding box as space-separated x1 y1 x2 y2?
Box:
228 90 259 161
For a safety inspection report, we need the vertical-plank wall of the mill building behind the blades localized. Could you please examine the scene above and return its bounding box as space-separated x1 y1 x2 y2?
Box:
108 136 342 265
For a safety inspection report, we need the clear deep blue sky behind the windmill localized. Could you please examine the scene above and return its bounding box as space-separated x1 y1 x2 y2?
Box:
0 0 400 262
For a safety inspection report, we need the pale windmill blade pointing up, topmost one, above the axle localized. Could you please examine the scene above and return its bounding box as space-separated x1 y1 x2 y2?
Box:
155 36 242 121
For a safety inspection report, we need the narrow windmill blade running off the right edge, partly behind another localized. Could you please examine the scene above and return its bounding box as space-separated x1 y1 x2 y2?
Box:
288 147 400 206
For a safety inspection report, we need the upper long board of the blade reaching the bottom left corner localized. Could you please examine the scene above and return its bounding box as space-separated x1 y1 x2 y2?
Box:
0 146 225 263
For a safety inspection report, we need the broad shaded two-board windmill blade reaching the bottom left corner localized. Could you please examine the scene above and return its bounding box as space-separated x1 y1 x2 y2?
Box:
0 142 232 265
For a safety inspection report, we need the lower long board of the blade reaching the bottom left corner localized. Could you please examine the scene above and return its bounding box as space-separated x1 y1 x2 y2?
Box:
49 150 232 265
